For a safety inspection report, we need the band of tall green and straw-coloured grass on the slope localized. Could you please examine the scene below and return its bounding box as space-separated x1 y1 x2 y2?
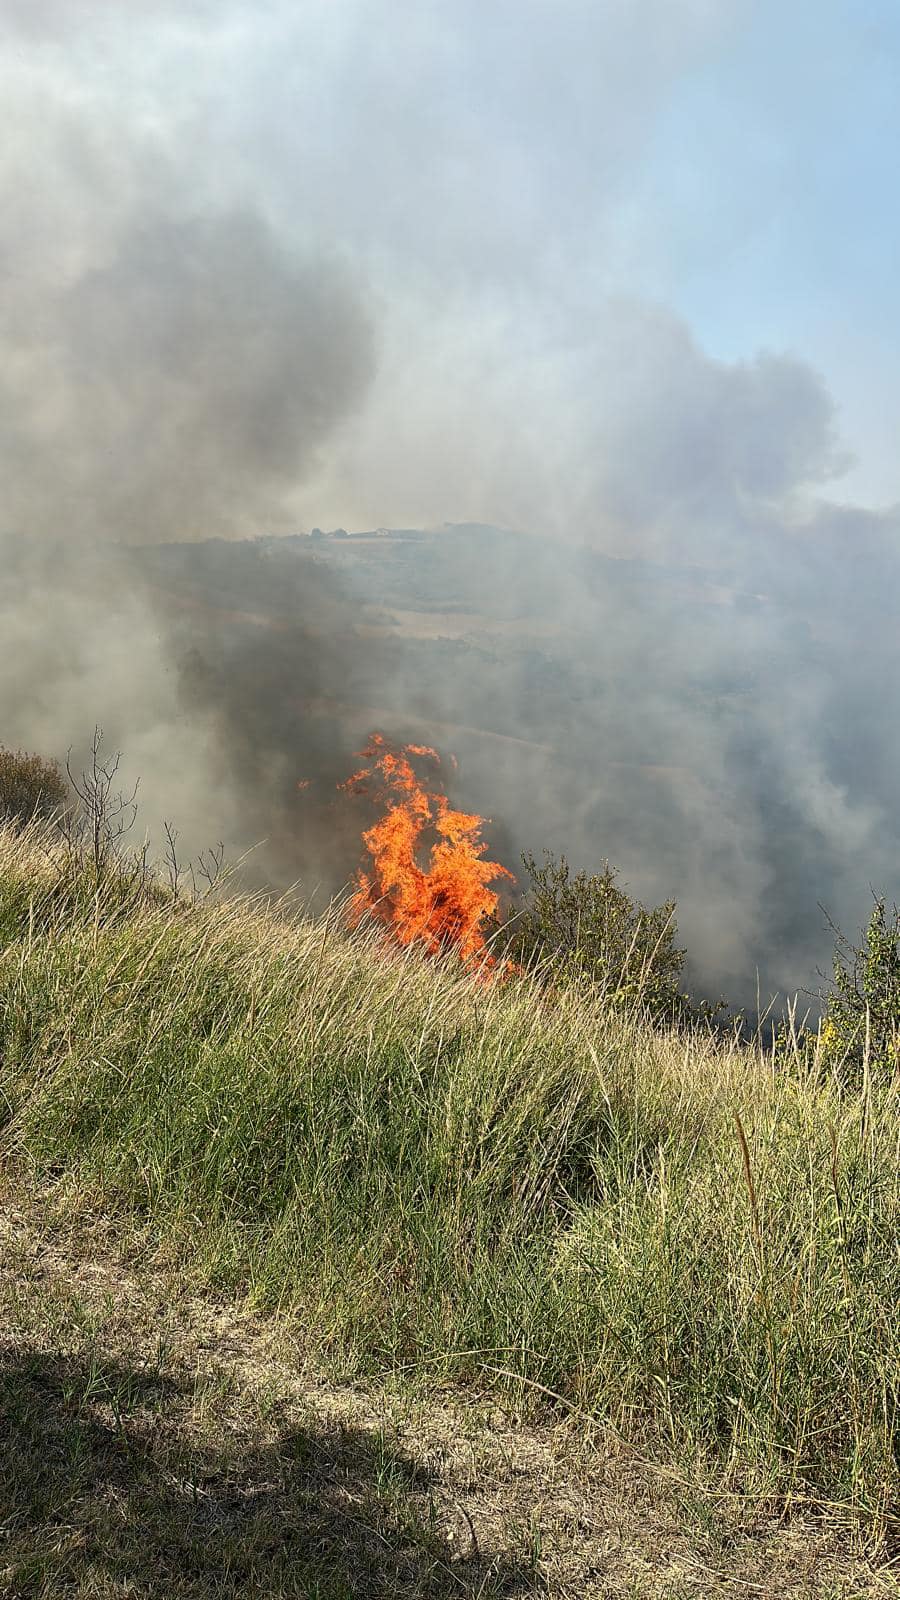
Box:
0 830 900 1526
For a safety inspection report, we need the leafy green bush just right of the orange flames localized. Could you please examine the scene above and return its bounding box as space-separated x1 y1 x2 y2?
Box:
504 851 687 1018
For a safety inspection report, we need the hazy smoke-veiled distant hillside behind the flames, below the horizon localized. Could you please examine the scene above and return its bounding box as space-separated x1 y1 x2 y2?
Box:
120 525 900 1008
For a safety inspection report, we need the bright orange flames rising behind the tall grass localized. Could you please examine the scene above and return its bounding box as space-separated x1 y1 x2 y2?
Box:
340 733 512 968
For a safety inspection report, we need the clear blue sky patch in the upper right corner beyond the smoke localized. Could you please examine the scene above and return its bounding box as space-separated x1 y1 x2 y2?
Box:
639 0 900 502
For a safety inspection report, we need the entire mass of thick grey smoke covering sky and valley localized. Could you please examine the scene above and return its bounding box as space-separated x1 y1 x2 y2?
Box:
0 0 900 1002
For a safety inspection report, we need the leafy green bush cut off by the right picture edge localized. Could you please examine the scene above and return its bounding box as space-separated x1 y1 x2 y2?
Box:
820 899 900 1078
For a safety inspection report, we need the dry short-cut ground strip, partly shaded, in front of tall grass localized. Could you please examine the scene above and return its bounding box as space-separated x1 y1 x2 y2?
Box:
0 1186 900 1600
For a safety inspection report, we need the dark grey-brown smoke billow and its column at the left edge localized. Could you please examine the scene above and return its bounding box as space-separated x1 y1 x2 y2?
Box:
0 204 372 848
